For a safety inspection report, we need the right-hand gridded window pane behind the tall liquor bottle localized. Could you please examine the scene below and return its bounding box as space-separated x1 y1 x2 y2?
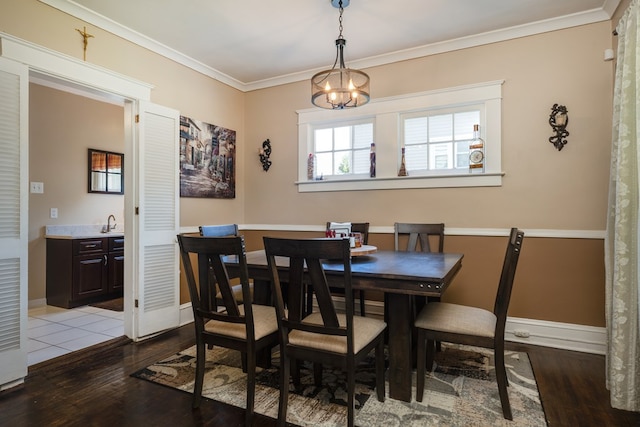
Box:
401 106 482 176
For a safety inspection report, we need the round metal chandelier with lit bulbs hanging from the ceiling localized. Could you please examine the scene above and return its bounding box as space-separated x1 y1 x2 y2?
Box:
311 0 369 110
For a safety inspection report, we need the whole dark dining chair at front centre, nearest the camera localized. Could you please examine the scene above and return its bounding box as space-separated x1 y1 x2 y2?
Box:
264 237 387 426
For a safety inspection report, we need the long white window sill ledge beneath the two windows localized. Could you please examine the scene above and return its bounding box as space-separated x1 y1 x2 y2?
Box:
295 172 504 193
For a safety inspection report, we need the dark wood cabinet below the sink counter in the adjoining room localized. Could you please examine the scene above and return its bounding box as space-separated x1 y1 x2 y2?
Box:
46 236 124 308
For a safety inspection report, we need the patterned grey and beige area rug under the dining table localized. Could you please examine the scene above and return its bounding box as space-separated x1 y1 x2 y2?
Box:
132 343 547 427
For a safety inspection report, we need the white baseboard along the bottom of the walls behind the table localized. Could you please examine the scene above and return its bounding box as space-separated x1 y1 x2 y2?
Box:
180 297 607 354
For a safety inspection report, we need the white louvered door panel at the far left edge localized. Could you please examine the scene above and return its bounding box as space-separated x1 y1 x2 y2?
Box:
0 58 29 390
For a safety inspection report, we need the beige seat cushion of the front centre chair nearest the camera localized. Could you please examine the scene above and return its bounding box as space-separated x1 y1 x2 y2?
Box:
289 312 387 354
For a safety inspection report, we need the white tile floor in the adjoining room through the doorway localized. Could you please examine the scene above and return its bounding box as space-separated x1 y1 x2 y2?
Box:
27 306 124 366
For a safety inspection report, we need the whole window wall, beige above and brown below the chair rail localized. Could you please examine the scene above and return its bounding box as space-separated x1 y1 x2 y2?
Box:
245 22 613 332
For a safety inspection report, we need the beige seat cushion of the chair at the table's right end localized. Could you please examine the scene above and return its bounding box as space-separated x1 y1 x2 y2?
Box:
415 302 496 338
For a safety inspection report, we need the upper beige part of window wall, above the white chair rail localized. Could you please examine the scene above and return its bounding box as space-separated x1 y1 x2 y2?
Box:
245 22 613 230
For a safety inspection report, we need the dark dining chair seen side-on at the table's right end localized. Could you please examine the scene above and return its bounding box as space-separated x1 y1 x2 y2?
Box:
415 228 524 420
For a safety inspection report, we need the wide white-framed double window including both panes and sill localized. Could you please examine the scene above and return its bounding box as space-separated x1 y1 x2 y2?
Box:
296 81 504 192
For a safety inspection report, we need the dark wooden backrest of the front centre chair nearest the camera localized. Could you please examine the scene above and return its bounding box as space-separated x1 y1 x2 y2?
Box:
263 237 353 349
